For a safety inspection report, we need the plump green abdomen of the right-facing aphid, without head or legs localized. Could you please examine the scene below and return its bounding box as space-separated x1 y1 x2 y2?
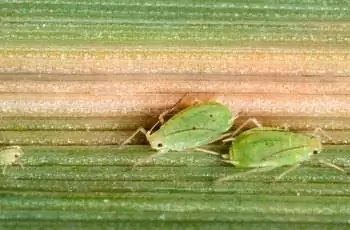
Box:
230 128 312 167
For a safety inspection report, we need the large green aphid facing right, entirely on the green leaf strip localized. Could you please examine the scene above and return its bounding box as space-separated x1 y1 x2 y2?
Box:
216 127 346 182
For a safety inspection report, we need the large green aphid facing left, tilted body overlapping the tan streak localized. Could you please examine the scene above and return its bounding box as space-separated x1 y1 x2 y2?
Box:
121 95 236 167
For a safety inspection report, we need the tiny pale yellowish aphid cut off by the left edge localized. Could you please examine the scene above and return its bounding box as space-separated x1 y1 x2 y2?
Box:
0 146 24 175
